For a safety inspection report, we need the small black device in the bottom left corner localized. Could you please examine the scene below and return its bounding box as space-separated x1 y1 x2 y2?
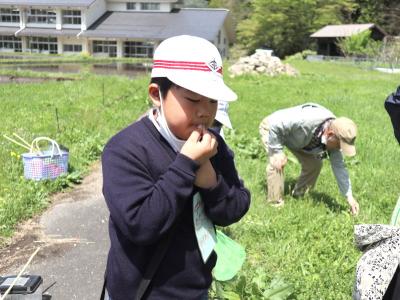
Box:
0 275 43 294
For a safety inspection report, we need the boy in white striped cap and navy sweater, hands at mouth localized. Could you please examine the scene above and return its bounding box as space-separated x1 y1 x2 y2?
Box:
102 36 250 300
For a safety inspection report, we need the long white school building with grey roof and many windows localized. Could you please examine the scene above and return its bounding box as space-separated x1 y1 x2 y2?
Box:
0 0 234 57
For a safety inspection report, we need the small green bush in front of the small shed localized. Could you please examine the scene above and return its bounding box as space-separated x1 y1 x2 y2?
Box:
337 30 382 57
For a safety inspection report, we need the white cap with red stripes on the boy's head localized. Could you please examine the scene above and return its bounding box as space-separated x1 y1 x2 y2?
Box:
151 35 237 101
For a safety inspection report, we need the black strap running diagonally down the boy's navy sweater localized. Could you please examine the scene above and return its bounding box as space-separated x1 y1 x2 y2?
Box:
135 224 176 300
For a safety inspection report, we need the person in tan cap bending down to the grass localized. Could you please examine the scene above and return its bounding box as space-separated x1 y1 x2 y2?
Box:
259 103 359 215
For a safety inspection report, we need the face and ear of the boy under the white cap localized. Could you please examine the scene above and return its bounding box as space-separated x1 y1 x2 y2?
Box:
149 85 218 140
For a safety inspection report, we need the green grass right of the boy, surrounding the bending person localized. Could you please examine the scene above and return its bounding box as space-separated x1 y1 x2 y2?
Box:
219 61 400 300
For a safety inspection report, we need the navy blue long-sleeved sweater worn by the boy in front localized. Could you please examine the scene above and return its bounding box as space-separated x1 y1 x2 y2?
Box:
102 117 250 300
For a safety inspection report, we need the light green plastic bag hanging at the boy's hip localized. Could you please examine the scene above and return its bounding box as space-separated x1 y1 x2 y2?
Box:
213 230 246 281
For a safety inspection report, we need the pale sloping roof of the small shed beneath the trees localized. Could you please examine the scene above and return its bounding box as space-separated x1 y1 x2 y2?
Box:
311 23 386 38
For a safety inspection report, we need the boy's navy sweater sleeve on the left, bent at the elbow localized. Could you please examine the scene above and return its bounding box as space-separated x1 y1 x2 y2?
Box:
102 147 198 245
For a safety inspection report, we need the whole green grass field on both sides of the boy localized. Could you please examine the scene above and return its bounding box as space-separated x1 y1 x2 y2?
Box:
0 61 400 300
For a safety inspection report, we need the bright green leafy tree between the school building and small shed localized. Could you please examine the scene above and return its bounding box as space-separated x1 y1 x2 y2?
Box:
237 0 356 57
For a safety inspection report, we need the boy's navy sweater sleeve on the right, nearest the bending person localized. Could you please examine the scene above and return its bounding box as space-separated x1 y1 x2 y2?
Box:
200 141 250 226
